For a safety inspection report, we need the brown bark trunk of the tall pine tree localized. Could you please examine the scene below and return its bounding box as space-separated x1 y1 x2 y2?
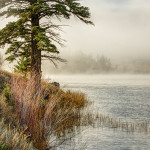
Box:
31 0 41 91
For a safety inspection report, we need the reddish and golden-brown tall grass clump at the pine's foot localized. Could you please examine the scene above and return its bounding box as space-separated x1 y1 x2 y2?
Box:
1 74 87 150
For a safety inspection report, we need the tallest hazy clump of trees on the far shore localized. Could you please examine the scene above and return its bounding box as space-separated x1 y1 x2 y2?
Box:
45 52 116 73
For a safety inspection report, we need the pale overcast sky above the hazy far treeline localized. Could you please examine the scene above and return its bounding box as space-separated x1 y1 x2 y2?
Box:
1 0 150 66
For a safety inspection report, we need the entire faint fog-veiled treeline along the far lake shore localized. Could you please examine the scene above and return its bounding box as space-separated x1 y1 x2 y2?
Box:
43 52 150 74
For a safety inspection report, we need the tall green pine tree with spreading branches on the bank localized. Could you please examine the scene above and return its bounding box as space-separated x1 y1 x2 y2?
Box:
0 0 92 84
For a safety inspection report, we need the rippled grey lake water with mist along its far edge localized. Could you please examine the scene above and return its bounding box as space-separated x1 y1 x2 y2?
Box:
49 75 150 150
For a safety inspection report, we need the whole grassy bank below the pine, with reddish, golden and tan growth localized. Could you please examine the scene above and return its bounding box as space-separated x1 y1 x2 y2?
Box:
0 71 88 150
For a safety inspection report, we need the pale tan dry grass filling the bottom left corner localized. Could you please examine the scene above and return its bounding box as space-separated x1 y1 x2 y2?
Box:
0 95 32 150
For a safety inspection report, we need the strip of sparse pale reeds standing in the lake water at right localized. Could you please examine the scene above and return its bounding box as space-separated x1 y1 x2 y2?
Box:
81 112 150 133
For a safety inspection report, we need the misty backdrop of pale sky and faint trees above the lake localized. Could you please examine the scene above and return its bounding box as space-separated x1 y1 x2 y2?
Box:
0 0 150 74
